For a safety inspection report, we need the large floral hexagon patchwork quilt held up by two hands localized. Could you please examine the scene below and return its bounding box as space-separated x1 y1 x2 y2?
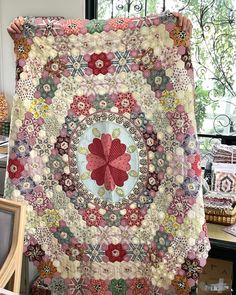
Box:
5 13 209 295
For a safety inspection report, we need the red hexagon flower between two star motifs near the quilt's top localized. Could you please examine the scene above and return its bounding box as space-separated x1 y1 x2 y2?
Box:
88 52 111 75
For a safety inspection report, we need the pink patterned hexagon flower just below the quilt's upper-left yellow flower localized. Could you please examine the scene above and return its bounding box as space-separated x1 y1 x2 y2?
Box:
18 113 44 144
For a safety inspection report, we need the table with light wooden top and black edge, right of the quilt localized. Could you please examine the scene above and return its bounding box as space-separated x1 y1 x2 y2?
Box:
207 223 236 295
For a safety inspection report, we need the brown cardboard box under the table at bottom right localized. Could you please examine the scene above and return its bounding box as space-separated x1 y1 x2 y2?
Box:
198 258 233 295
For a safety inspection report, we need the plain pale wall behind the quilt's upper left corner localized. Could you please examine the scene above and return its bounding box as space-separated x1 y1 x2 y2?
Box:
0 0 85 116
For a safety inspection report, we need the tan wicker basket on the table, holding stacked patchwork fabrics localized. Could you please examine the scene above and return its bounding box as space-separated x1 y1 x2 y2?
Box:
205 206 236 225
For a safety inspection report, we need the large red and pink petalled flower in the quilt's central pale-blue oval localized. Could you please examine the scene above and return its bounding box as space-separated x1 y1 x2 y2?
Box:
86 134 131 191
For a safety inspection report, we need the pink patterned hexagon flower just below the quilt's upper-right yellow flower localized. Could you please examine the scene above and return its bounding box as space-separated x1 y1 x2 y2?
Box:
166 105 194 142
